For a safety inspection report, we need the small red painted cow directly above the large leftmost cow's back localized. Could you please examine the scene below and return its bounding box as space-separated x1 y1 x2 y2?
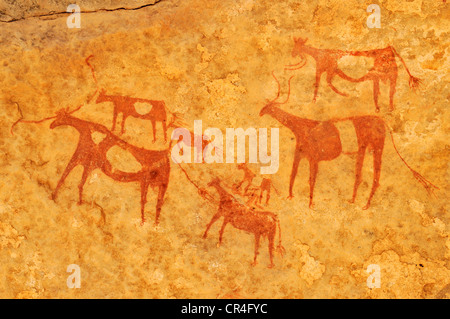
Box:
96 89 179 142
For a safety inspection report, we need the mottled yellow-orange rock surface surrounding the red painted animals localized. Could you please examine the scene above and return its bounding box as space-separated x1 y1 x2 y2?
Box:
0 0 450 298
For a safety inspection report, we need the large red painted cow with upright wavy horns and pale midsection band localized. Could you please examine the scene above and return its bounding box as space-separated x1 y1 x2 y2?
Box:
260 74 437 209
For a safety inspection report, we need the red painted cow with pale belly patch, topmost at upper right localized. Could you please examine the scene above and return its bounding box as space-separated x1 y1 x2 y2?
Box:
287 38 421 112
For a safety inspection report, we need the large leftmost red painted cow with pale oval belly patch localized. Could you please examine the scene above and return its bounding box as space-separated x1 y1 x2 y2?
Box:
50 110 170 224
